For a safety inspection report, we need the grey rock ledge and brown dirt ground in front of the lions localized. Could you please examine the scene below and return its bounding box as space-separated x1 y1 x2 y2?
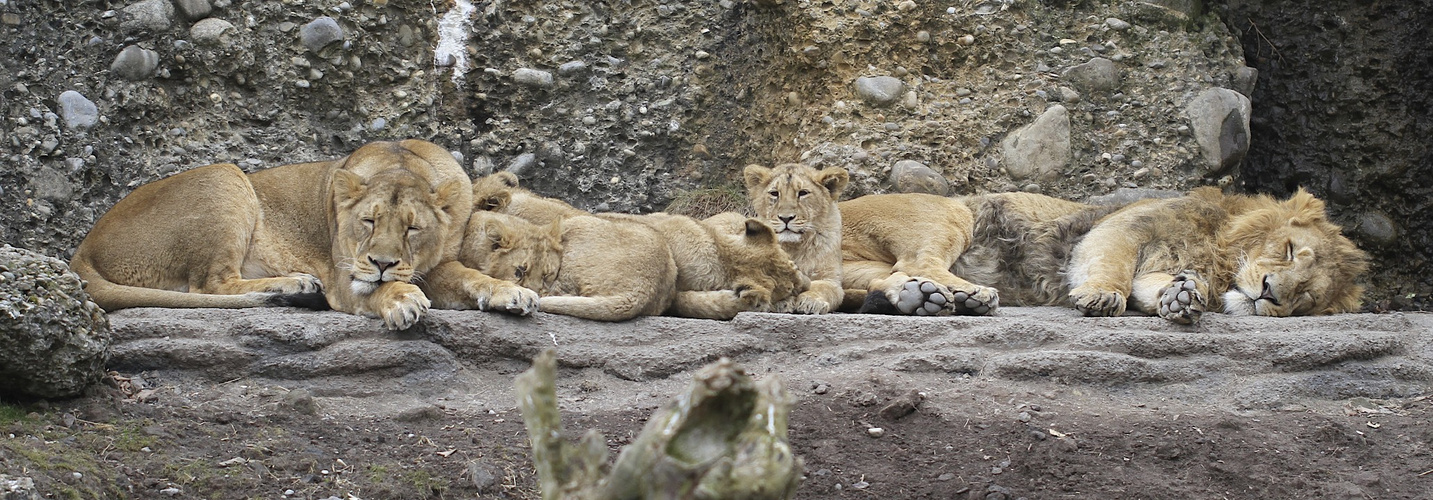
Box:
0 308 1433 499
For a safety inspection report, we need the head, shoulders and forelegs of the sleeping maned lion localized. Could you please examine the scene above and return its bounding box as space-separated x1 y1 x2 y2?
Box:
1069 188 1369 324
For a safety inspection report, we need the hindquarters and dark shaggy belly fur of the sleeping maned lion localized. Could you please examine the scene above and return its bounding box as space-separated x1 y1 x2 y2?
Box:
838 193 1113 315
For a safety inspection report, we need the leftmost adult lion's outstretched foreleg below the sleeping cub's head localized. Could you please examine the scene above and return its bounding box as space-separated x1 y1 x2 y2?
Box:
423 261 537 315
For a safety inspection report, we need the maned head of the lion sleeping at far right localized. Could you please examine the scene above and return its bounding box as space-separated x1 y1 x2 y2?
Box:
1224 189 1369 317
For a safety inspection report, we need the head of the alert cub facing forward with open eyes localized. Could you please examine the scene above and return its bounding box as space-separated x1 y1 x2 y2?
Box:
744 163 850 244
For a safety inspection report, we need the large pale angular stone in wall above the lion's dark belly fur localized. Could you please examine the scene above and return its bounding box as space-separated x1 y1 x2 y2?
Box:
1002 105 1070 181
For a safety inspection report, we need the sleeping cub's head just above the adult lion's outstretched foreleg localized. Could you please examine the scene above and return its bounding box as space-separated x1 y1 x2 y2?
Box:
459 208 562 292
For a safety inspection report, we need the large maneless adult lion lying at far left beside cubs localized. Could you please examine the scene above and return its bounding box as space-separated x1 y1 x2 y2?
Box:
70 139 537 330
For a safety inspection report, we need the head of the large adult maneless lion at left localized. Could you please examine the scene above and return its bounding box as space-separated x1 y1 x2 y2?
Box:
331 168 469 295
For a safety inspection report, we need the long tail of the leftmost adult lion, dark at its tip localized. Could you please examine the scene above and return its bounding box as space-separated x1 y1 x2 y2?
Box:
70 256 328 312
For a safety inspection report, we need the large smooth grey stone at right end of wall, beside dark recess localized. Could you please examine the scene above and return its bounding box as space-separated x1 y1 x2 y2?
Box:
1185 87 1252 176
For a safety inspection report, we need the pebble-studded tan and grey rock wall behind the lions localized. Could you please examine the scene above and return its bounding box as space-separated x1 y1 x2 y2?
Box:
0 0 1401 303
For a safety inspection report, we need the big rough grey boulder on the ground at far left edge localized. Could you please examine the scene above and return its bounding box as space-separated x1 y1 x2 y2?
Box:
0 245 110 398
